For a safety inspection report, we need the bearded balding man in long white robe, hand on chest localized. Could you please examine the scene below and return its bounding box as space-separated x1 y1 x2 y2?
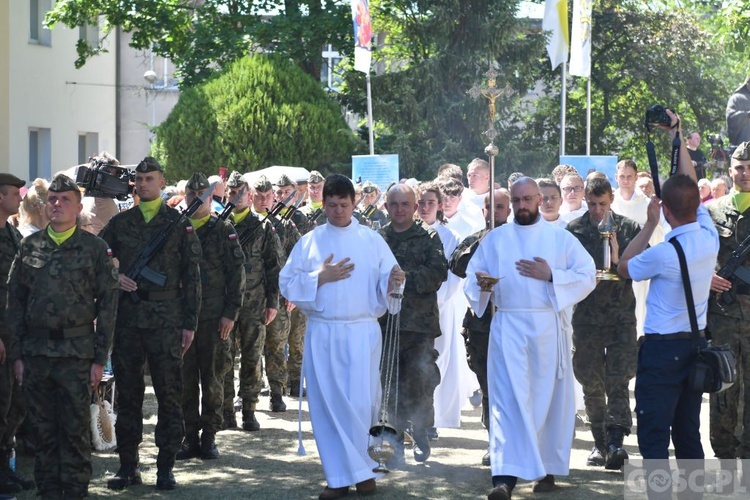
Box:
464 177 596 500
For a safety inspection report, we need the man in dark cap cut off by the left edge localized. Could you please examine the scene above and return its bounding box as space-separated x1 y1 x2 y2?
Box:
0 174 34 493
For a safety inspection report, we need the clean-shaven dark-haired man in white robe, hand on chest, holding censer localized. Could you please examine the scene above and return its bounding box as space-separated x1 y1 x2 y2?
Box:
279 175 404 500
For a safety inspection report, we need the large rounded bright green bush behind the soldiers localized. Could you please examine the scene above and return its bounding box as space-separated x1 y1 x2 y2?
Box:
154 55 362 181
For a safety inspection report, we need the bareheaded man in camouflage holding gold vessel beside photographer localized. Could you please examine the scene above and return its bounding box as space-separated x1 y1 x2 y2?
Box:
567 177 640 469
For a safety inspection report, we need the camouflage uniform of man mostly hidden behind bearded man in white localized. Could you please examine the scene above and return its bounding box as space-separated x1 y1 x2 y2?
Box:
448 229 492 431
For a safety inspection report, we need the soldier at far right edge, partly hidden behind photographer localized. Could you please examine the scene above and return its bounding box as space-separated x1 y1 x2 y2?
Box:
706 142 750 459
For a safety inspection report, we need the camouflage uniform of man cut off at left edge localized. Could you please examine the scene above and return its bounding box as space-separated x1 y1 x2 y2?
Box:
0 217 26 474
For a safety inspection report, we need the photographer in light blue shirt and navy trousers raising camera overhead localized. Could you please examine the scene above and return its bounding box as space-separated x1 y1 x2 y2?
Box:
617 109 719 472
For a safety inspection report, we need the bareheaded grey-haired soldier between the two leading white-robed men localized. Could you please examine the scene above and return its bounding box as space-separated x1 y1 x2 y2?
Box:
380 184 448 467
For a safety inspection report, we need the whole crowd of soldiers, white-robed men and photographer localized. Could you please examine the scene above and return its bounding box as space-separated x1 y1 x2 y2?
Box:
0 112 750 500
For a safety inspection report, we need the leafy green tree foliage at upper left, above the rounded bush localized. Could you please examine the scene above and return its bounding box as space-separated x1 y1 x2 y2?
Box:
46 0 353 85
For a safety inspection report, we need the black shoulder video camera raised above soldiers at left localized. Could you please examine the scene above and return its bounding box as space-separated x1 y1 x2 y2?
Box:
76 156 135 201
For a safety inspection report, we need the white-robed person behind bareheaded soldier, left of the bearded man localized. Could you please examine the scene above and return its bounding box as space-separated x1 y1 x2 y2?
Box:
417 182 471 428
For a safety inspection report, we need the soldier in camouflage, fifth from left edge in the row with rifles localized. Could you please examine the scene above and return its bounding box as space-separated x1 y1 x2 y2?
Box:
224 172 284 431
